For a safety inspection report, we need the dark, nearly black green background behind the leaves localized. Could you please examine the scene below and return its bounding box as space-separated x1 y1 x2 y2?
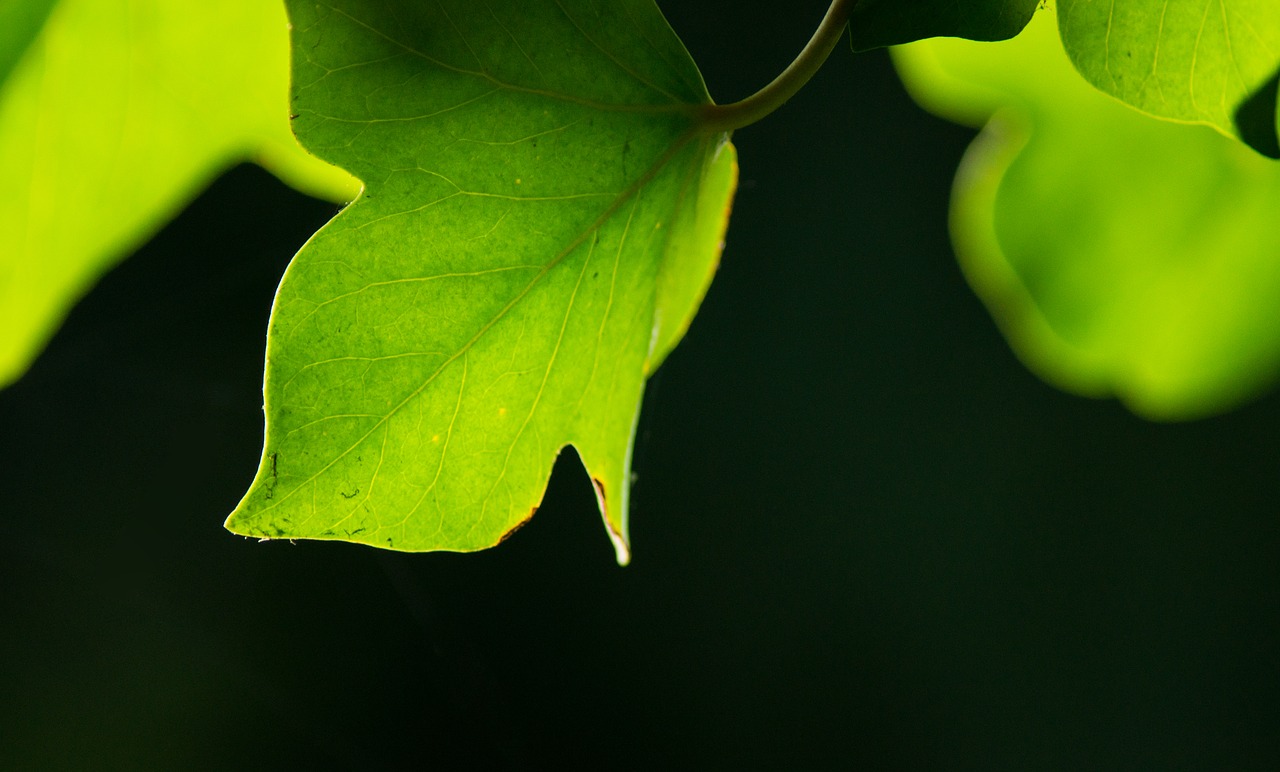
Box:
0 0 1280 769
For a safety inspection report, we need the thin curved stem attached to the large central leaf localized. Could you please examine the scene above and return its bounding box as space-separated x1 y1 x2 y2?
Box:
699 0 856 132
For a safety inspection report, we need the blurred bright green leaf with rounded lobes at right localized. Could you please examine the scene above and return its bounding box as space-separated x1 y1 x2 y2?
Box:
895 4 1280 419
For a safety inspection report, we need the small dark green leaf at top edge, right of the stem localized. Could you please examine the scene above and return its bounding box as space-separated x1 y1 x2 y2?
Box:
849 0 1041 51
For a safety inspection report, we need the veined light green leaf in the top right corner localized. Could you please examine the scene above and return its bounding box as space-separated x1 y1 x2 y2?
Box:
1059 0 1280 157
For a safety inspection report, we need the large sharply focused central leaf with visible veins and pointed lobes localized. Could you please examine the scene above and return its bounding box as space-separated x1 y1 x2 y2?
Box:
228 0 736 562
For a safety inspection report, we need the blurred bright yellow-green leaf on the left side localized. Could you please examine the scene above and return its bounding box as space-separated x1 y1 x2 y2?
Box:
0 0 357 385
